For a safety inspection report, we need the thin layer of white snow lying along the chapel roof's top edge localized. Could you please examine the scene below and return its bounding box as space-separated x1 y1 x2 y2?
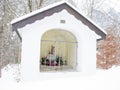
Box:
11 1 107 40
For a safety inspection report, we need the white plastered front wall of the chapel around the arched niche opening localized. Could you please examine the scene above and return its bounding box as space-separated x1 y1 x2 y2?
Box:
20 10 96 80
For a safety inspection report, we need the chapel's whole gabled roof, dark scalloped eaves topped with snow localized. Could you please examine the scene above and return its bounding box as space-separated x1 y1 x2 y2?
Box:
11 1 107 39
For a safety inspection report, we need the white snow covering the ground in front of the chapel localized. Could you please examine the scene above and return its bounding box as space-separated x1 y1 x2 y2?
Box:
0 65 120 90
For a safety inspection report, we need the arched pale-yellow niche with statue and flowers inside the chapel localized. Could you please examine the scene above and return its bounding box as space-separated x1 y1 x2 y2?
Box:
40 30 77 72
